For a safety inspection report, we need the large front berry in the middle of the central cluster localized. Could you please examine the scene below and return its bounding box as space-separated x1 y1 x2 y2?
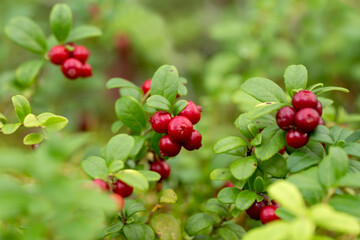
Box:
168 116 193 142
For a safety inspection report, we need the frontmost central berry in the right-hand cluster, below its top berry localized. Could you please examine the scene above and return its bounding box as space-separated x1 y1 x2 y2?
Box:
295 108 320 132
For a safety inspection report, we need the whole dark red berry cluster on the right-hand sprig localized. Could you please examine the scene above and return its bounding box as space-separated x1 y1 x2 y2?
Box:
276 90 325 148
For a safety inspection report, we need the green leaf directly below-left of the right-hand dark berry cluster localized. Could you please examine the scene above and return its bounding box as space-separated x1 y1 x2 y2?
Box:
255 125 286 161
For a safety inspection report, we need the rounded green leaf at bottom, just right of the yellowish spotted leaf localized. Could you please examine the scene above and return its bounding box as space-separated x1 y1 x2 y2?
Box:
185 213 216 236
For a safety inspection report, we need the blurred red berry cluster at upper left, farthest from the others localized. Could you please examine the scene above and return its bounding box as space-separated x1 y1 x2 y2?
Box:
48 44 92 79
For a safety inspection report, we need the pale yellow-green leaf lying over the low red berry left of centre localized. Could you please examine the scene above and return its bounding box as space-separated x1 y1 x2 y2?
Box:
115 169 149 191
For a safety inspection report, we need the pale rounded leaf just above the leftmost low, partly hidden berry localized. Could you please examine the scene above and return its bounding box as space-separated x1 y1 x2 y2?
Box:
81 156 108 181
